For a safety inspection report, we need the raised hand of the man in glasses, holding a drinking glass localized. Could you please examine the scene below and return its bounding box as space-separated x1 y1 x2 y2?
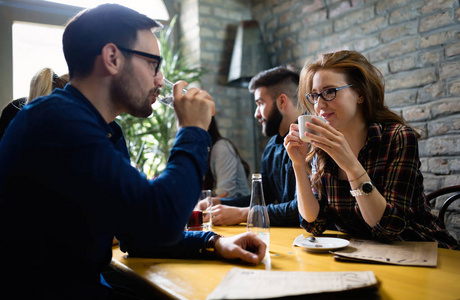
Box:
173 81 215 131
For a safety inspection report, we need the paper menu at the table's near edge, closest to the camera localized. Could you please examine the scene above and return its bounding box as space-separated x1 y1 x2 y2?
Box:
206 267 377 300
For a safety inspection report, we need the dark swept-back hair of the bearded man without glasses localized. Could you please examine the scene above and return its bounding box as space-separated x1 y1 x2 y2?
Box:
248 66 299 106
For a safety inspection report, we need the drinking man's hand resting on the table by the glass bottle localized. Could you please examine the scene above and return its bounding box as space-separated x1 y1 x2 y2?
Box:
215 232 267 264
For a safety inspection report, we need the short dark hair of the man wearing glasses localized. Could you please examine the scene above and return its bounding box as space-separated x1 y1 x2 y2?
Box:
62 4 162 79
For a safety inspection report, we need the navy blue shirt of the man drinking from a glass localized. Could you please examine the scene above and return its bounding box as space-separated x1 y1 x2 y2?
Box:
0 85 213 299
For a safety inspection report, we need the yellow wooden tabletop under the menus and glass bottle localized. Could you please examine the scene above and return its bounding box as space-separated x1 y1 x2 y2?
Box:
112 226 460 300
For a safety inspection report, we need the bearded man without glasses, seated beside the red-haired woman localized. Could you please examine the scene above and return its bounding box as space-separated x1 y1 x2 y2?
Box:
204 66 302 226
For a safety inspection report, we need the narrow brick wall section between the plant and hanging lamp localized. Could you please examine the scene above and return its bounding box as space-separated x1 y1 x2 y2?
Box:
177 0 267 173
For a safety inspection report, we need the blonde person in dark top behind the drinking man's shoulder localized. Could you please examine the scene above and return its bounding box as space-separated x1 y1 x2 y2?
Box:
0 68 69 140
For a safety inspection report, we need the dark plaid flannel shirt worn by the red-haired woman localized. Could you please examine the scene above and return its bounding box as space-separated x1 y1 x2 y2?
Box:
301 124 460 249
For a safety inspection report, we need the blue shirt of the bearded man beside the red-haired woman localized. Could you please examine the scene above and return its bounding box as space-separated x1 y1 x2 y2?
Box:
221 134 300 226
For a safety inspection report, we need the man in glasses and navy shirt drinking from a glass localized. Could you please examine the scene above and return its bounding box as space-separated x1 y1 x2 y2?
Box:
0 4 266 299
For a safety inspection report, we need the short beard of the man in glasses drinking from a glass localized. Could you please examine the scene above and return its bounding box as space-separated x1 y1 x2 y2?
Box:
110 63 158 118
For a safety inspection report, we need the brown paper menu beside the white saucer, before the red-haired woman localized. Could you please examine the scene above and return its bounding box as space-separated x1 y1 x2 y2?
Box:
334 239 438 267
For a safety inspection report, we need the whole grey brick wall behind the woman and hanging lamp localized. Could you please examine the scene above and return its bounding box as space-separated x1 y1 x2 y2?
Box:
173 0 460 237
